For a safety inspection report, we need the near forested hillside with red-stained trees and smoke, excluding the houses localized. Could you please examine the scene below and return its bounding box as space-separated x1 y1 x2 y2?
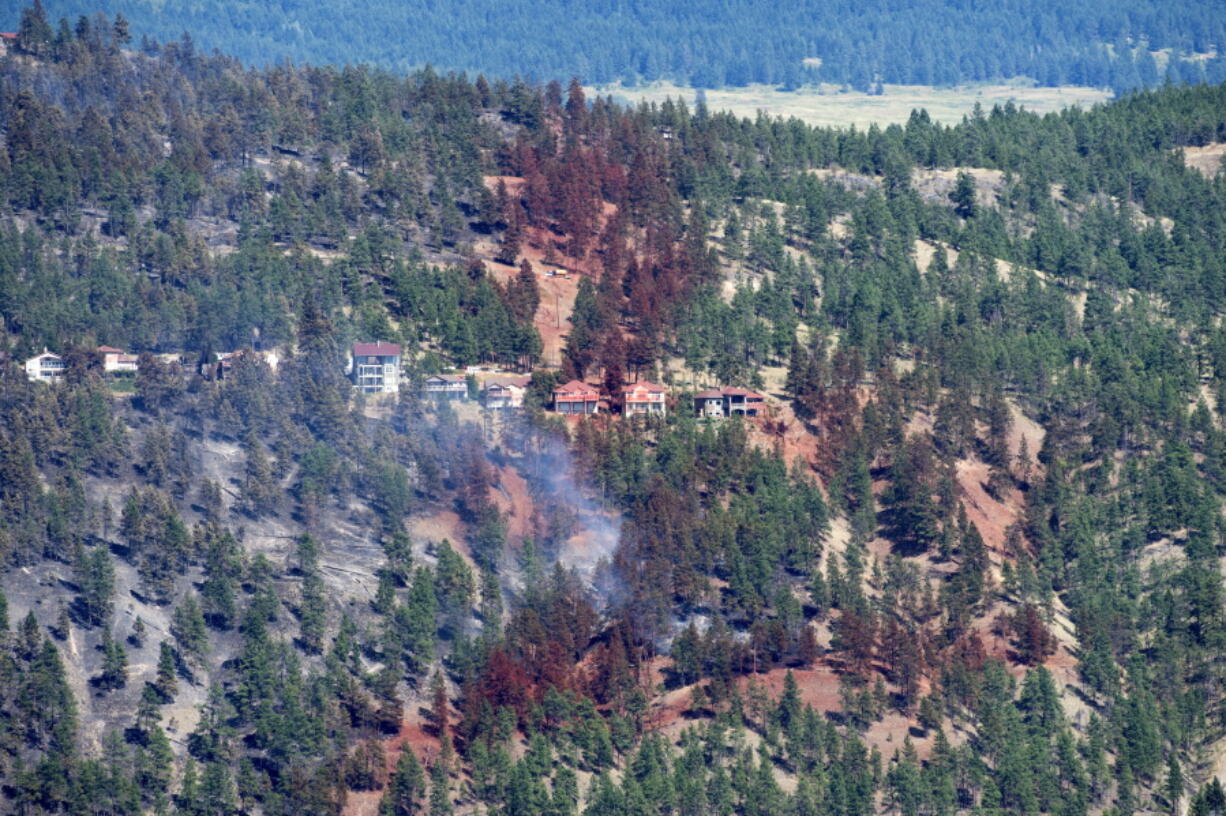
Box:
0 10 1226 816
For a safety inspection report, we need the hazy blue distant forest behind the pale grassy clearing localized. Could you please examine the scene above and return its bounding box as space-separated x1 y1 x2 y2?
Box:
33 0 1226 89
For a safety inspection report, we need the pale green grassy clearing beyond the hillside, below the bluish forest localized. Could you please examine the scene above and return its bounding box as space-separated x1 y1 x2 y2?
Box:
590 80 1111 129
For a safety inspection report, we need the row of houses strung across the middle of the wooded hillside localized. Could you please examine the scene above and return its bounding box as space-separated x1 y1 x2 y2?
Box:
25 342 766 419
